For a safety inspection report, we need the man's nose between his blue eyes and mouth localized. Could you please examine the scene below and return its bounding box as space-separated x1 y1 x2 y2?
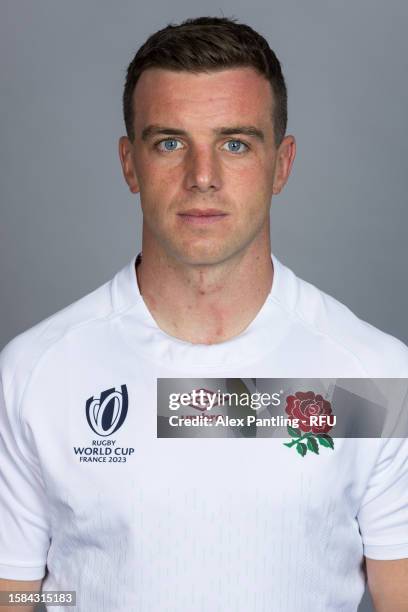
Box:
184 147 221 193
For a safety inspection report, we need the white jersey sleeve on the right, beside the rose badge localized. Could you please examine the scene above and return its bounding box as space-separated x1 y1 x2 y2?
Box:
357 384 408 560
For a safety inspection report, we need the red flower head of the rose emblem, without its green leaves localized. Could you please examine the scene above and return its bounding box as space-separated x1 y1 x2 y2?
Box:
286 391 332 434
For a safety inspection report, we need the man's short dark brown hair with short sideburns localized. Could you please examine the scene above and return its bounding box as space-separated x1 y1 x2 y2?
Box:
123 17 287 146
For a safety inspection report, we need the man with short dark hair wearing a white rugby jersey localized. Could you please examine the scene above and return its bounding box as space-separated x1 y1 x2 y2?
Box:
0 17 408 612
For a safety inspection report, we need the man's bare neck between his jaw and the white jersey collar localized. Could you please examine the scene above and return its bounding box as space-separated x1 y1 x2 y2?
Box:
137 232 273 344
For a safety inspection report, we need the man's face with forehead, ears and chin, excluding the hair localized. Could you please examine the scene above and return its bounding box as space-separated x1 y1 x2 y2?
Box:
119 68 295 265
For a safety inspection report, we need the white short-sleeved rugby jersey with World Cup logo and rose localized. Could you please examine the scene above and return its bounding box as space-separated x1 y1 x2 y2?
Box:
0 255 408 612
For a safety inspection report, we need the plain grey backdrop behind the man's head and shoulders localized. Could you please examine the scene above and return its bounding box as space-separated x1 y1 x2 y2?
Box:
0 0 408 612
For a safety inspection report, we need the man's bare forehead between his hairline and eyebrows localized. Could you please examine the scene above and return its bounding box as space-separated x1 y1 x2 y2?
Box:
133 67 273 127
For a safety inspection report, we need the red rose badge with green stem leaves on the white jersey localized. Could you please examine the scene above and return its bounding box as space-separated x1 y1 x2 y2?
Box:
283 391 336 457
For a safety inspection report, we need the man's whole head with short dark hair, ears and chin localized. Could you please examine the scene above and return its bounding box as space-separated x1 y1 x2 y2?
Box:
119 17 295 264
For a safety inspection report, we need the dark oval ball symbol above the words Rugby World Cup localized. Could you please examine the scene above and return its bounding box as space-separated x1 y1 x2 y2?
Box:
86 385 128 437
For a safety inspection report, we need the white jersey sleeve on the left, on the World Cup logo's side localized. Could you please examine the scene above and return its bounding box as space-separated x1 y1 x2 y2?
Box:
0 359 50 580
